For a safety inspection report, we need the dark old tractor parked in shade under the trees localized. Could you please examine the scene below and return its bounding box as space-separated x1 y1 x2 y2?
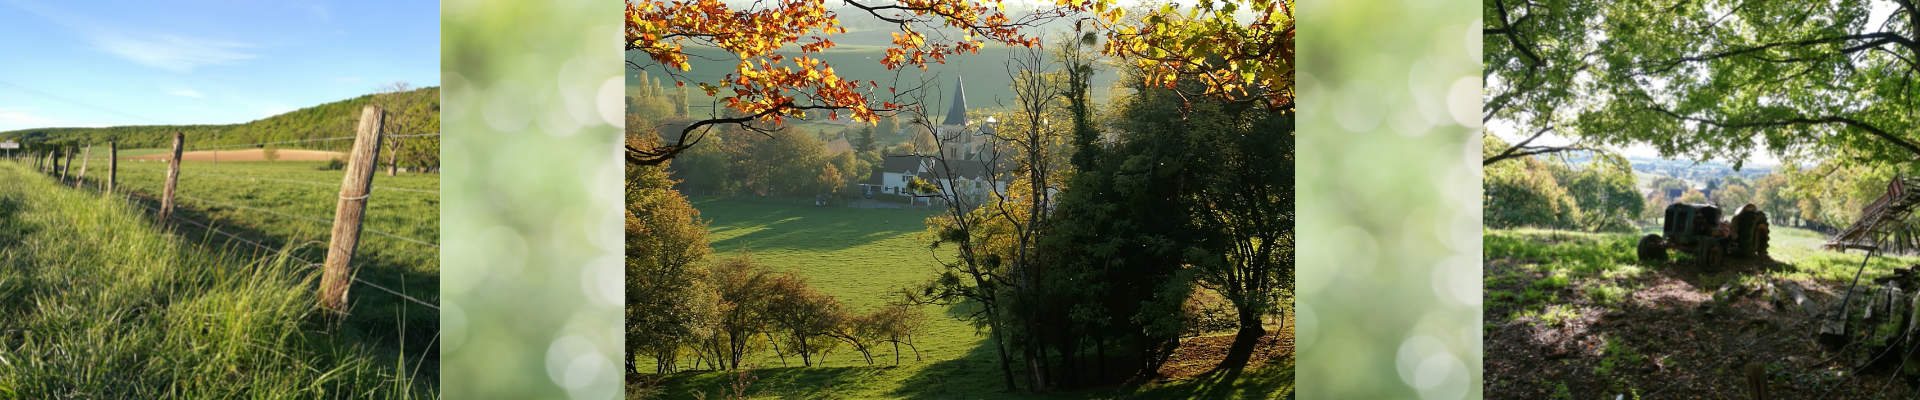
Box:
1636 202 1768 269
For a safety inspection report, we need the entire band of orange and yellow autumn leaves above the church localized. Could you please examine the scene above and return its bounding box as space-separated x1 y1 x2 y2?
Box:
626 0 1294 163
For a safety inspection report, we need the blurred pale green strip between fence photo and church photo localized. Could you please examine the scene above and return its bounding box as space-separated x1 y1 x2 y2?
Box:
440 0 624 400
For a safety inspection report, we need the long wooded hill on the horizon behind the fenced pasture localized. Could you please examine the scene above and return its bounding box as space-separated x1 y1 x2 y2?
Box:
0 87 440 150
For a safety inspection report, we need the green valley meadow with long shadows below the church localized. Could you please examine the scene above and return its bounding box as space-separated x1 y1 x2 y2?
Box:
641 198 1292 398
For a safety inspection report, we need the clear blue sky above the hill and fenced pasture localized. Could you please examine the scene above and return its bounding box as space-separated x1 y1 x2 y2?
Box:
0 0 440 131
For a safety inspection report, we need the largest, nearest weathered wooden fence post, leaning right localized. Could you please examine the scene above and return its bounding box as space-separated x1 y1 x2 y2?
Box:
321 106 386 313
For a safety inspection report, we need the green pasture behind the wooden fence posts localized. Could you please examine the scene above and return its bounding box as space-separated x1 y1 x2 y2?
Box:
54 160 440 380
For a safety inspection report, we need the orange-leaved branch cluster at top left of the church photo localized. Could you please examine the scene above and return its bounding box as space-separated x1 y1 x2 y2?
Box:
626 0 1098 163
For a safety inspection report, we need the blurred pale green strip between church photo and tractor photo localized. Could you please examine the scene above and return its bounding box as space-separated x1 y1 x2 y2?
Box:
1296 0 1482 400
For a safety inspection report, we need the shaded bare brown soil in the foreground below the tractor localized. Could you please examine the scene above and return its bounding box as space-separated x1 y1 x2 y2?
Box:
1484 258 1914 398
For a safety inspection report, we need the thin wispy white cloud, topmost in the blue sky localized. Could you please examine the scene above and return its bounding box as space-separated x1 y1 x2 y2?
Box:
13 2 255 73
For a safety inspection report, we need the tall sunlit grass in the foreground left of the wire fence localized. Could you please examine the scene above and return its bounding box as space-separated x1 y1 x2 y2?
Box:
0 162 438 398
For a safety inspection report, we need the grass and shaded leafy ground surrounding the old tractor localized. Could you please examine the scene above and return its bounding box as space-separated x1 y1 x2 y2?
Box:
1482 227 1920 398
